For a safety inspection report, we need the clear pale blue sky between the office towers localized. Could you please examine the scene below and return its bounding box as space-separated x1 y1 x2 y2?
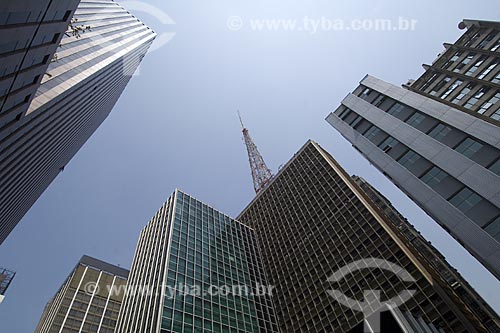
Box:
0 0 500 333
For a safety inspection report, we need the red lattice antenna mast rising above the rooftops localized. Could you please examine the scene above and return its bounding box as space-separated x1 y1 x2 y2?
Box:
238 111 273 194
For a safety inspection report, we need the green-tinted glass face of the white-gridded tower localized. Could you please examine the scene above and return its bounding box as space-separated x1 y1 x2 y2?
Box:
161 191 278 333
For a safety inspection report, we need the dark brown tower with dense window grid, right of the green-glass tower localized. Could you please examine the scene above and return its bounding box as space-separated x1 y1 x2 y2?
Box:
238 141 496 332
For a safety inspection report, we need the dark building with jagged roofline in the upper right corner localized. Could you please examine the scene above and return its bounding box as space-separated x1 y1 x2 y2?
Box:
405 20 500 121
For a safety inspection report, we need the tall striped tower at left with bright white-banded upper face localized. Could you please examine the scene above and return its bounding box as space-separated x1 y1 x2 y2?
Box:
0 0 155 243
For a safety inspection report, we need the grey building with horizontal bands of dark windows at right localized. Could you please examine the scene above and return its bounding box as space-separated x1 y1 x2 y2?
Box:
327 76 500 278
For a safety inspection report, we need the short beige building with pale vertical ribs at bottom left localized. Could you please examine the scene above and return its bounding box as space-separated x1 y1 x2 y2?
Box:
35 256 128 333
